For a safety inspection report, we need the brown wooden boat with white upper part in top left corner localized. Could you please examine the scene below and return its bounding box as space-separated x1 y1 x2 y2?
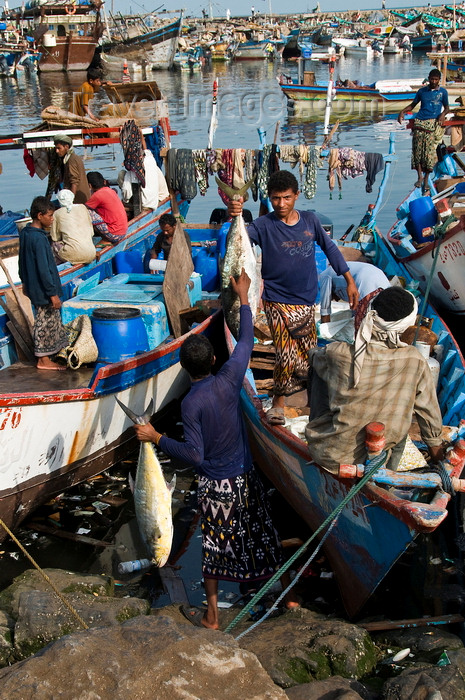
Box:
12 0 103 72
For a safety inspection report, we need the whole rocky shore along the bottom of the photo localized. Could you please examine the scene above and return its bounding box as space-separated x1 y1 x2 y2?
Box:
0 569 465 700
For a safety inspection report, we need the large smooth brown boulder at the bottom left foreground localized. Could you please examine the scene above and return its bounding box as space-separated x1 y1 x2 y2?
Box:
0 615 287 700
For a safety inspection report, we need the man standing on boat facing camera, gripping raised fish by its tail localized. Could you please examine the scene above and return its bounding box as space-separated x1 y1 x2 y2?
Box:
228 170 359 425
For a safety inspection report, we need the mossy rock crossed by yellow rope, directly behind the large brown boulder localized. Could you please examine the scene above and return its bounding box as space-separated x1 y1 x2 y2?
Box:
14 591 150 659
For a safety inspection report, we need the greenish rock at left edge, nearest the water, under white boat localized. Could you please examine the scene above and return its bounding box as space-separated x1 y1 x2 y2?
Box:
0 569 114 620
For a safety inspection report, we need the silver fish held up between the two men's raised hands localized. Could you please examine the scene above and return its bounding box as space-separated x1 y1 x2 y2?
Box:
216 178 261 340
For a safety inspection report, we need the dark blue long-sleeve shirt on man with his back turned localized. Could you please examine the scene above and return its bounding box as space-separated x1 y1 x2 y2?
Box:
159 306 253 479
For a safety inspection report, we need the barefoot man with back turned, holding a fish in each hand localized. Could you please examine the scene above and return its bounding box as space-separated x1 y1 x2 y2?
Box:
134 269 299 629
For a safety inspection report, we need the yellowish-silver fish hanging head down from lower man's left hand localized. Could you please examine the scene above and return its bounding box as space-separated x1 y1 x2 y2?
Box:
116 399 176 567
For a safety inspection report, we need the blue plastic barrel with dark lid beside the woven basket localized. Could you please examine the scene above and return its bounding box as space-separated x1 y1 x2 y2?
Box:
91 306 149 363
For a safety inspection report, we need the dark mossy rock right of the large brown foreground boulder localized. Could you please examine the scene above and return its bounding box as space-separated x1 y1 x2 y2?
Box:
239 608 376 688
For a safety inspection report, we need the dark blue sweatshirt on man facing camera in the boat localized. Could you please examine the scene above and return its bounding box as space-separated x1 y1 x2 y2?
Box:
247 211 349 306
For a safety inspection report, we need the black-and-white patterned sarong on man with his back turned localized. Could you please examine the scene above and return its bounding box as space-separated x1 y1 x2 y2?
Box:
197 467 281 582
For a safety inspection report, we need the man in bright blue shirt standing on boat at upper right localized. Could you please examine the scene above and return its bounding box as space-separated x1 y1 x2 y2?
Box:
397 68 449 195
